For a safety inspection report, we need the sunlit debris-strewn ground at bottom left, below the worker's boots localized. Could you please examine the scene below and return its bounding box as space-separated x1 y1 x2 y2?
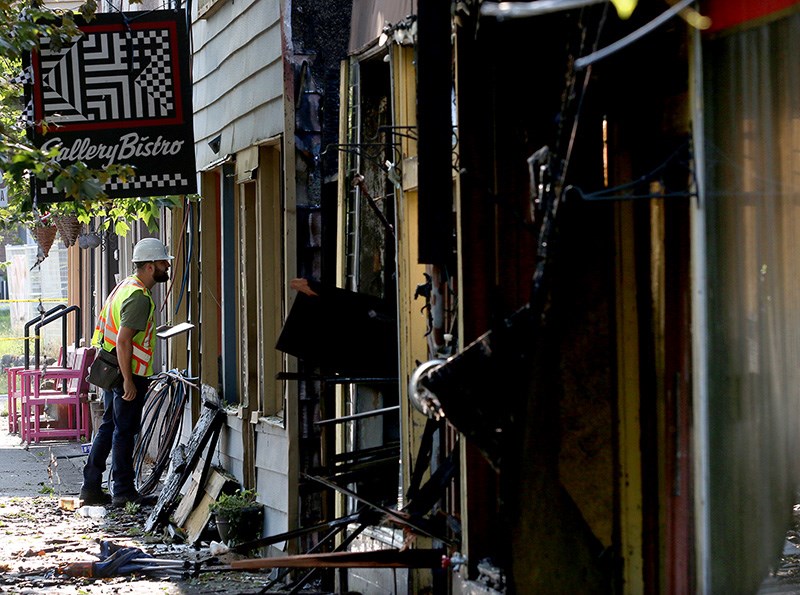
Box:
0 495 278 595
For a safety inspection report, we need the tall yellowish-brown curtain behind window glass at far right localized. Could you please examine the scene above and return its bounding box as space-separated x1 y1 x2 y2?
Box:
704 15 800 593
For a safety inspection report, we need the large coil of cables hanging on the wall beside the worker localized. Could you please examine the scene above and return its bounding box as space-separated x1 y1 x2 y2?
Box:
133 370 197 495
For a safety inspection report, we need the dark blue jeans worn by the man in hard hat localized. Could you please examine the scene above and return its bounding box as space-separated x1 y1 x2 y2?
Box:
83 375 150 496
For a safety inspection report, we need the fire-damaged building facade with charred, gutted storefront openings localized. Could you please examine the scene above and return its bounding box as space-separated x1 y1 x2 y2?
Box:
64 0 800 593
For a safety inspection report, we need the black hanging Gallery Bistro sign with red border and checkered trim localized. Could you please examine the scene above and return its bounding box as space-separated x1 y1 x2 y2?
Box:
28 11 197 201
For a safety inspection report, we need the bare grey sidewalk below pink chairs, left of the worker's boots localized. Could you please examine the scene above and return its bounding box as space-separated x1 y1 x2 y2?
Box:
0 428 88 497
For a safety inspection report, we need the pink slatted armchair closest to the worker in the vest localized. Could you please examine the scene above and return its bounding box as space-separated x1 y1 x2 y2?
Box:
17 347 95 444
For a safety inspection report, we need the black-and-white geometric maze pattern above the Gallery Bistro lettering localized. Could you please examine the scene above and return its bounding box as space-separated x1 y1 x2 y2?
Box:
39 28 175 125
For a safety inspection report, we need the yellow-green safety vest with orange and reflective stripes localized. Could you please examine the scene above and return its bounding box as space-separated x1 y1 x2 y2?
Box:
92 275 156 376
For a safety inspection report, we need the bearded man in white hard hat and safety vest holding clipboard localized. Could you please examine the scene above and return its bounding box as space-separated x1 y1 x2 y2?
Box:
80 238 173 506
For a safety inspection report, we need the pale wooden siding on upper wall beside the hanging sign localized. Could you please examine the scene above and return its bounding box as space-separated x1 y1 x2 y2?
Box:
192 0 284 169
